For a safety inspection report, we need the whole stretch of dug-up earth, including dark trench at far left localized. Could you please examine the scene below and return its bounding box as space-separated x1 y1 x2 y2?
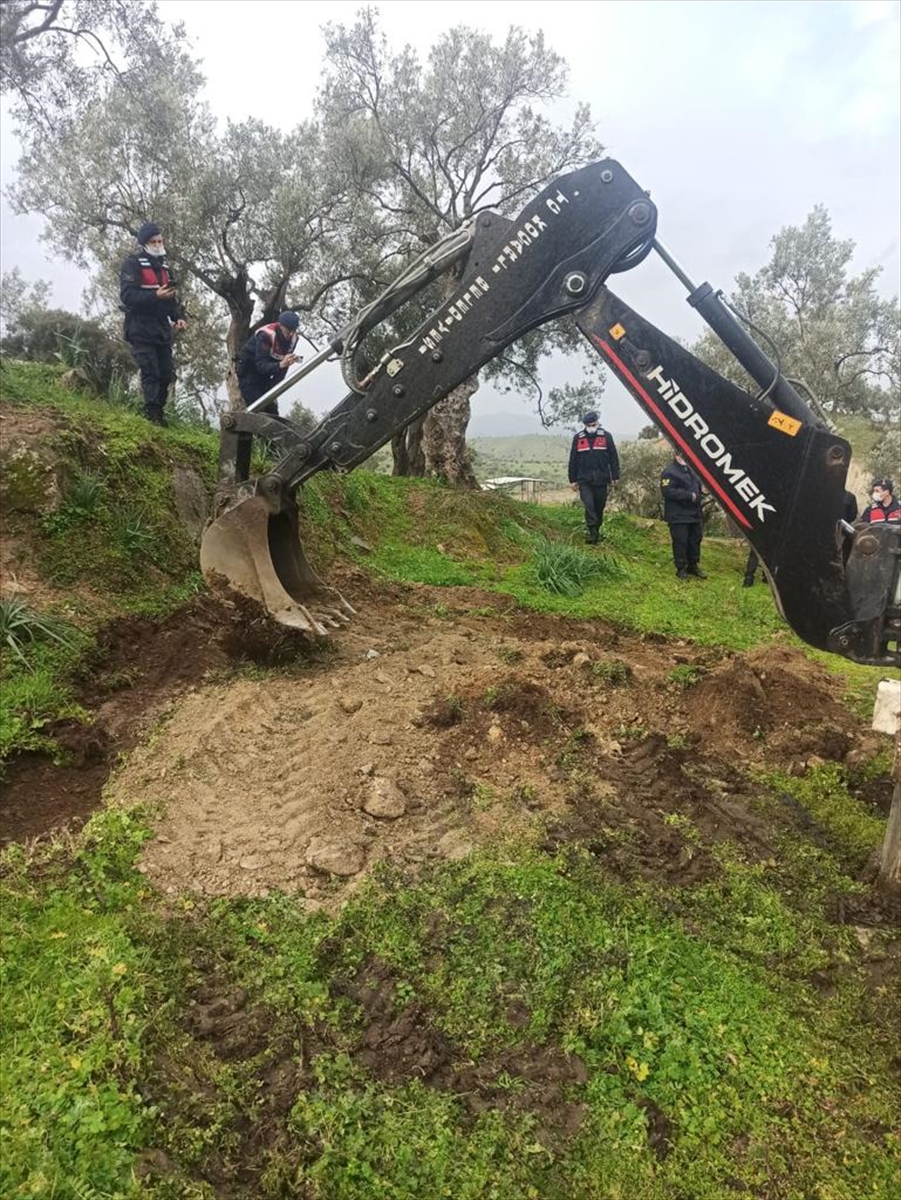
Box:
2 572 890 907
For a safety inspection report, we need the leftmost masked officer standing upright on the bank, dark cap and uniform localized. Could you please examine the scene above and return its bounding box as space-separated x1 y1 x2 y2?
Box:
119 221 187 425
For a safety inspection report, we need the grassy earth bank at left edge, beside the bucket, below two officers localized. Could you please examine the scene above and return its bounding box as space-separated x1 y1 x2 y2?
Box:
0 360 217 762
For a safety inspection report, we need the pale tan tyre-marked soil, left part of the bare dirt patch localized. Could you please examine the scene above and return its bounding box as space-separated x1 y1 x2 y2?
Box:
110 631 508 899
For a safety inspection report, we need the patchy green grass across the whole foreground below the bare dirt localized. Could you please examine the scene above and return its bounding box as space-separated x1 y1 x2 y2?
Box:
0 810 901 1200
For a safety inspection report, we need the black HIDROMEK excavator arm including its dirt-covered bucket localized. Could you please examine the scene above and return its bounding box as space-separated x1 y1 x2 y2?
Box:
202 160 901 665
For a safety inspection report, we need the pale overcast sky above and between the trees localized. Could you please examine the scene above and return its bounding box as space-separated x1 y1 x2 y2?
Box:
0 0 901 434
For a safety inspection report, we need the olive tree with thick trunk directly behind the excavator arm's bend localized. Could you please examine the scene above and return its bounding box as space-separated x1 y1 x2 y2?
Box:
317 8 601 486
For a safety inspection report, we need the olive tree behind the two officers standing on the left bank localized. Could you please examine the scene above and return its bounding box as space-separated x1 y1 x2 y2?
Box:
11 37 355 403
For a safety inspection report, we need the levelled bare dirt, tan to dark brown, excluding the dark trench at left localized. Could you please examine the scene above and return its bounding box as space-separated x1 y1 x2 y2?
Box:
93 583 873 907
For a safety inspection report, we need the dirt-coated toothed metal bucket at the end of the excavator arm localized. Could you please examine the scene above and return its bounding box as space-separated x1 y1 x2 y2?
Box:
200 496 354 636
